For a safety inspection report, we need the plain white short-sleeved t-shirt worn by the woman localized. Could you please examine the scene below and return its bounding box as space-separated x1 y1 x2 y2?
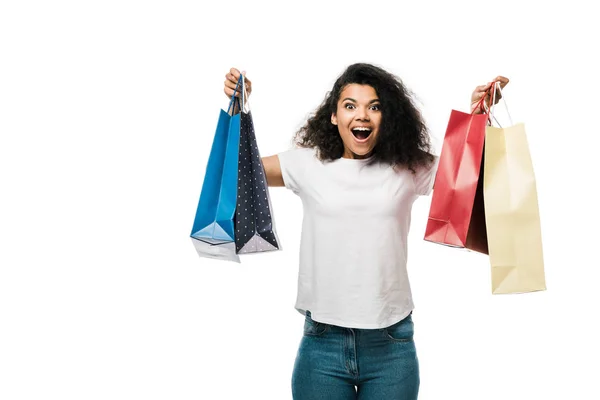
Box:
278 148 439 329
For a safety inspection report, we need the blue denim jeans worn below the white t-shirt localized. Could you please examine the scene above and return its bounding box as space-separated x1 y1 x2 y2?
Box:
292 312 420 400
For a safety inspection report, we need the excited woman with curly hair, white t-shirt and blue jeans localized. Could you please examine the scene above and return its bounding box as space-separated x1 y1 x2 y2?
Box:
225 64 508 400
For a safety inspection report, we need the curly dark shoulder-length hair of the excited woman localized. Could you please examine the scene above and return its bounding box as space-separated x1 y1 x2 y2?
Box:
294 63 434 172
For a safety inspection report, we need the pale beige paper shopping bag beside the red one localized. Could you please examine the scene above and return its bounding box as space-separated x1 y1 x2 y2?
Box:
483 85 546 294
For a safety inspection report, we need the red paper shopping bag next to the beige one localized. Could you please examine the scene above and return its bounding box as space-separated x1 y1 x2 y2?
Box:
424 92 488 254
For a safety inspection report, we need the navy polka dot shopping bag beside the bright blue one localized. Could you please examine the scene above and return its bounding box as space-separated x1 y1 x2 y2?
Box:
235 79 280 254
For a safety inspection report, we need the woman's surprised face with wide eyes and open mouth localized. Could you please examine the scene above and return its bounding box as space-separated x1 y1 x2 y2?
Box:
331 83 381 158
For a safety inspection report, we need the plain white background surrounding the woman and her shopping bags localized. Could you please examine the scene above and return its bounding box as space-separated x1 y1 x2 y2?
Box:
0 0 600 400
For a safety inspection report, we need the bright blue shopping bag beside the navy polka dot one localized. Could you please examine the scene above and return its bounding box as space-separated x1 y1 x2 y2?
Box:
190 80 243 262
